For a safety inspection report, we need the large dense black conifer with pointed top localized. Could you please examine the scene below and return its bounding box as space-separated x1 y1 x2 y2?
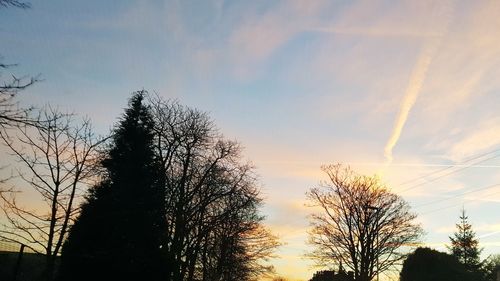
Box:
60 92 166 280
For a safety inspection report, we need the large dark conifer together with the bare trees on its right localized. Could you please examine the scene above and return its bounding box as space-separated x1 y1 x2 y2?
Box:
61 92 277 280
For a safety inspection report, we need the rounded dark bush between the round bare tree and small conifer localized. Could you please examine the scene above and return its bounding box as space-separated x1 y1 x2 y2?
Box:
399 248 472 281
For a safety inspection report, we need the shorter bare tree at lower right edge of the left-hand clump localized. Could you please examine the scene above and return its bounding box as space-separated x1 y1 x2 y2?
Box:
198 187 278 280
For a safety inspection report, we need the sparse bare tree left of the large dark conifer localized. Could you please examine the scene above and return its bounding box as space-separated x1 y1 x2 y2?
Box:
0 107 103 280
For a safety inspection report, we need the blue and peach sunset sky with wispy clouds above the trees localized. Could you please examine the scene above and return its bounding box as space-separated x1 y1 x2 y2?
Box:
0 0 500 281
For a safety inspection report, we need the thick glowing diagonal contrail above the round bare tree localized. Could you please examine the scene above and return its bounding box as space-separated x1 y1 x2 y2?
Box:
384 2 452 165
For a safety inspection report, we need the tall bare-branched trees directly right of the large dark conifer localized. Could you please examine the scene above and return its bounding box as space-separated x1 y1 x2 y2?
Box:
146 96 278 281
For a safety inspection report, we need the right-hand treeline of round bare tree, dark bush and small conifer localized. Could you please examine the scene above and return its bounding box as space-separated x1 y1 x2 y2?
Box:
282 164 500 281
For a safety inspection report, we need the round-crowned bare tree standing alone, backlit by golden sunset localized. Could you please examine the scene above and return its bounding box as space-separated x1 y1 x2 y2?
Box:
307 165 422 281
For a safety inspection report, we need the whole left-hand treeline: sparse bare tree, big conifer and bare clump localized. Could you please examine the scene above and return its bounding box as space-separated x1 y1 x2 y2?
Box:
0 91 279 281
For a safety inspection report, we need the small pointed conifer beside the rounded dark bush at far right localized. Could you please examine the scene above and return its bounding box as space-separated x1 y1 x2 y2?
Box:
450 209 482 271
